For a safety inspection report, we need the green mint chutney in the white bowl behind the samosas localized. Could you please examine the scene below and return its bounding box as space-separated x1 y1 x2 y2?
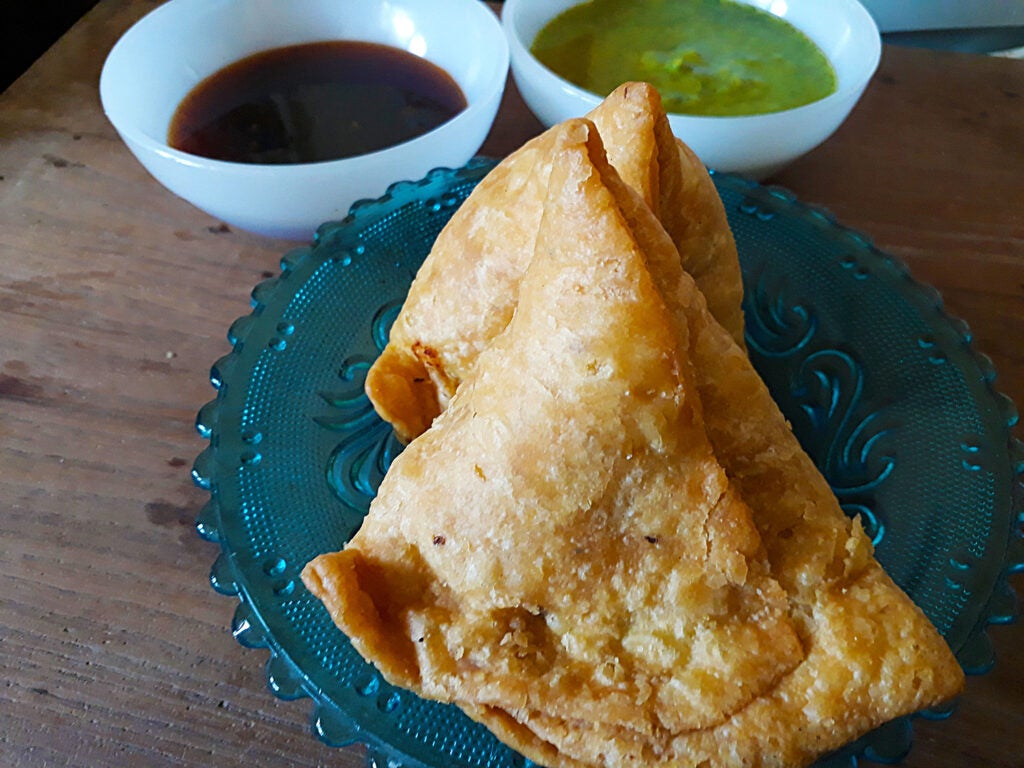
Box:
530 0 836 115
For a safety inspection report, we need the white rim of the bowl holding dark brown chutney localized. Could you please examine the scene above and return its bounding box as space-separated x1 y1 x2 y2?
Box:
98 0 511 176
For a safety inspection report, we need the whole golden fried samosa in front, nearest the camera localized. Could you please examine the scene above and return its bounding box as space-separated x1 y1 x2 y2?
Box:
303 121 962 768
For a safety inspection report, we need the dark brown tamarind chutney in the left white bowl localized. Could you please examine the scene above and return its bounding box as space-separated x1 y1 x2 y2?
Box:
168 40 466 165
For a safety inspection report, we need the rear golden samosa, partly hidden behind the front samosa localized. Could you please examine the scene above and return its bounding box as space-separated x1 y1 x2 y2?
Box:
367 83 742 441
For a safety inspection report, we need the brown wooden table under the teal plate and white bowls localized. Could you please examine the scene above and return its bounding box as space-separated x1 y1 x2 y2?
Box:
0 0 1024 768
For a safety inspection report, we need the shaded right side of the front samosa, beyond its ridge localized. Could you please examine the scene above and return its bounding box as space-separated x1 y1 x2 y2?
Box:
556 120 964 766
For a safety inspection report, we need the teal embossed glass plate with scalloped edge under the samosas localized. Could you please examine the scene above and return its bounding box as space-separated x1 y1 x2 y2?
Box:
193 159 1024 768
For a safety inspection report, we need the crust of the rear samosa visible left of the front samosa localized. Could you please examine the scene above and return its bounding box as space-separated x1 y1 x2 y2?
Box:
366 126 551 442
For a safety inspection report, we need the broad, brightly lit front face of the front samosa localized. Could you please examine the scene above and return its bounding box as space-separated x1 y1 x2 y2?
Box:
305 121 803 761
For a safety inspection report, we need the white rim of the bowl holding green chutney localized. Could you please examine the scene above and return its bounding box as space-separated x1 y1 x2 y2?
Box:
502 0 882 124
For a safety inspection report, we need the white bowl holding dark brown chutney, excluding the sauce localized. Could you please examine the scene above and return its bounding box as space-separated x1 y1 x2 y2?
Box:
99 0 508 240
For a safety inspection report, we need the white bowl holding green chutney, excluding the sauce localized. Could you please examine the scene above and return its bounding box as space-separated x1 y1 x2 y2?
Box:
502 0 882 178
